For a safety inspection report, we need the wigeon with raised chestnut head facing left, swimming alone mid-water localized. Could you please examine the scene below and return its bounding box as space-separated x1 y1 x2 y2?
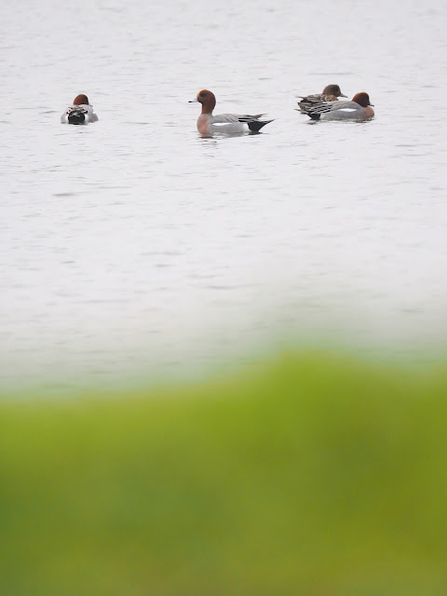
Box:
189 89 272 136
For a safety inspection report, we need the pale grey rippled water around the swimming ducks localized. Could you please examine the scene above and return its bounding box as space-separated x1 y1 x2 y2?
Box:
0 0 447 390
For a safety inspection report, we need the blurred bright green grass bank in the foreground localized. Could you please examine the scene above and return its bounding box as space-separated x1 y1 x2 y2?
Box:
0 352 447 596
